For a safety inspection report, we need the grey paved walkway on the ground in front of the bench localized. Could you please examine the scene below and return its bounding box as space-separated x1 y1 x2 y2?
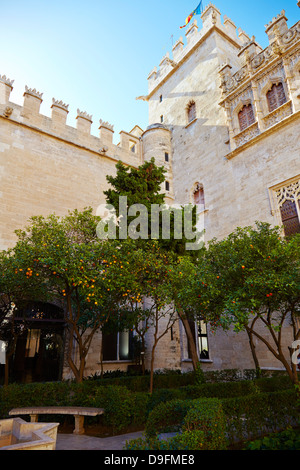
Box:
56 431 143 450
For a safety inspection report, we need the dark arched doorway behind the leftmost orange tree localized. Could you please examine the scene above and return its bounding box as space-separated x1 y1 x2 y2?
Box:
10 302 65 383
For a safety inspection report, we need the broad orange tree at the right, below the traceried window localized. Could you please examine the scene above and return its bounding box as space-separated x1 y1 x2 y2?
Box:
181 222 300 384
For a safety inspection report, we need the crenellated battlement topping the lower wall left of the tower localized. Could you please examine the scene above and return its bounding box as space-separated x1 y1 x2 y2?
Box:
0 75 142 165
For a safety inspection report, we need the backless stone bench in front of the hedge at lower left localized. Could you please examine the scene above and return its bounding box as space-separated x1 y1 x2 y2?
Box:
9 406 104 434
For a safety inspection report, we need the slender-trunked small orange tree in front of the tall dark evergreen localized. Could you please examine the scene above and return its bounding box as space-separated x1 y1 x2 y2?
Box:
103 239 178 393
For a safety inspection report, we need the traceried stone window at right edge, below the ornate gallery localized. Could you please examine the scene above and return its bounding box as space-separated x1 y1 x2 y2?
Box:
276 180 300 237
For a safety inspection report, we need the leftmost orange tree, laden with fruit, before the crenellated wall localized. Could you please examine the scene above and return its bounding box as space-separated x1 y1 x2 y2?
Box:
7 209 124 382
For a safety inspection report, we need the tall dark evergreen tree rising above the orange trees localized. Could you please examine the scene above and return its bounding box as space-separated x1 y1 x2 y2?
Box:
104 158 199 369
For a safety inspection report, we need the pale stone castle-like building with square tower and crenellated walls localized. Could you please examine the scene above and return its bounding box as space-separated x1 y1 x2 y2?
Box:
0 4 300 377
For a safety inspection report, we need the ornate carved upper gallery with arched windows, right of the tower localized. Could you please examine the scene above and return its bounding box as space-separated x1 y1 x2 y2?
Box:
219 10 300 154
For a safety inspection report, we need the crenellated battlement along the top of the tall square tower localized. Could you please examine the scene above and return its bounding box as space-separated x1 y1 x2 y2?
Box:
148 3 251 98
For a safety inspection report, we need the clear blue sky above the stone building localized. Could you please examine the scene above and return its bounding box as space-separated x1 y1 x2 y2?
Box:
0 0 300 139
